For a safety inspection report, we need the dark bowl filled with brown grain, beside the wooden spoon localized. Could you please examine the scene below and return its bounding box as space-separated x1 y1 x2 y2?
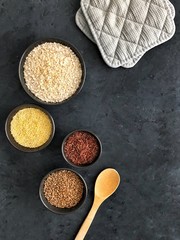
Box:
39 168 88 214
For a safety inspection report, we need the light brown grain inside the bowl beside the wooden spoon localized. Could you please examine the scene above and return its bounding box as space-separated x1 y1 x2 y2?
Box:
44 170 84 208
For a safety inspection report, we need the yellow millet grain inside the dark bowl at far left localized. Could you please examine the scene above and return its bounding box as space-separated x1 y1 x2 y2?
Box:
10 108 52 148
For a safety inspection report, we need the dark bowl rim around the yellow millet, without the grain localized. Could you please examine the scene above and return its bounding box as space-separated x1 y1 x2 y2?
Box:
5 104 55 152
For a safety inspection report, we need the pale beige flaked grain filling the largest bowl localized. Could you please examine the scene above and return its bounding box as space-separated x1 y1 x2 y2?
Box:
24 42 82 103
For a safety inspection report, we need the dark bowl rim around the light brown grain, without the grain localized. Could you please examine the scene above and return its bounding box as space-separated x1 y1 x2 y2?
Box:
39 168 88 214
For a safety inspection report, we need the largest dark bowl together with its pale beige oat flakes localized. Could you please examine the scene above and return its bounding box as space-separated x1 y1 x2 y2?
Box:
19 38 86 105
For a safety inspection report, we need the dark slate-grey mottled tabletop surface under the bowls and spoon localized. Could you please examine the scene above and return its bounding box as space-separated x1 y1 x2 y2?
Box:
0 0 180 240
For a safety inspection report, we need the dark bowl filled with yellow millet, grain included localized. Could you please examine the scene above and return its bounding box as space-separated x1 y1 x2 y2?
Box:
5 104 55 152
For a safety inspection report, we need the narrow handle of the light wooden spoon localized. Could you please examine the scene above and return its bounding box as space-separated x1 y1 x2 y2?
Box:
75 199 101 240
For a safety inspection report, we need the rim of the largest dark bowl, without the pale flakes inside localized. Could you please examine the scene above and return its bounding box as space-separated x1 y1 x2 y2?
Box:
19 38 86 105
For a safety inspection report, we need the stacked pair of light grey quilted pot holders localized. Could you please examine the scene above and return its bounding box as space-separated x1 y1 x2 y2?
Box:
76 0 175 68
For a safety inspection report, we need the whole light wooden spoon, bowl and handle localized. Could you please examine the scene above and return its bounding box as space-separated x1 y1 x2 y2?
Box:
75 168 120 240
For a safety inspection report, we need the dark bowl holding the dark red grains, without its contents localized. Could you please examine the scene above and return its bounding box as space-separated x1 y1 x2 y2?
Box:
61 129 102 168
